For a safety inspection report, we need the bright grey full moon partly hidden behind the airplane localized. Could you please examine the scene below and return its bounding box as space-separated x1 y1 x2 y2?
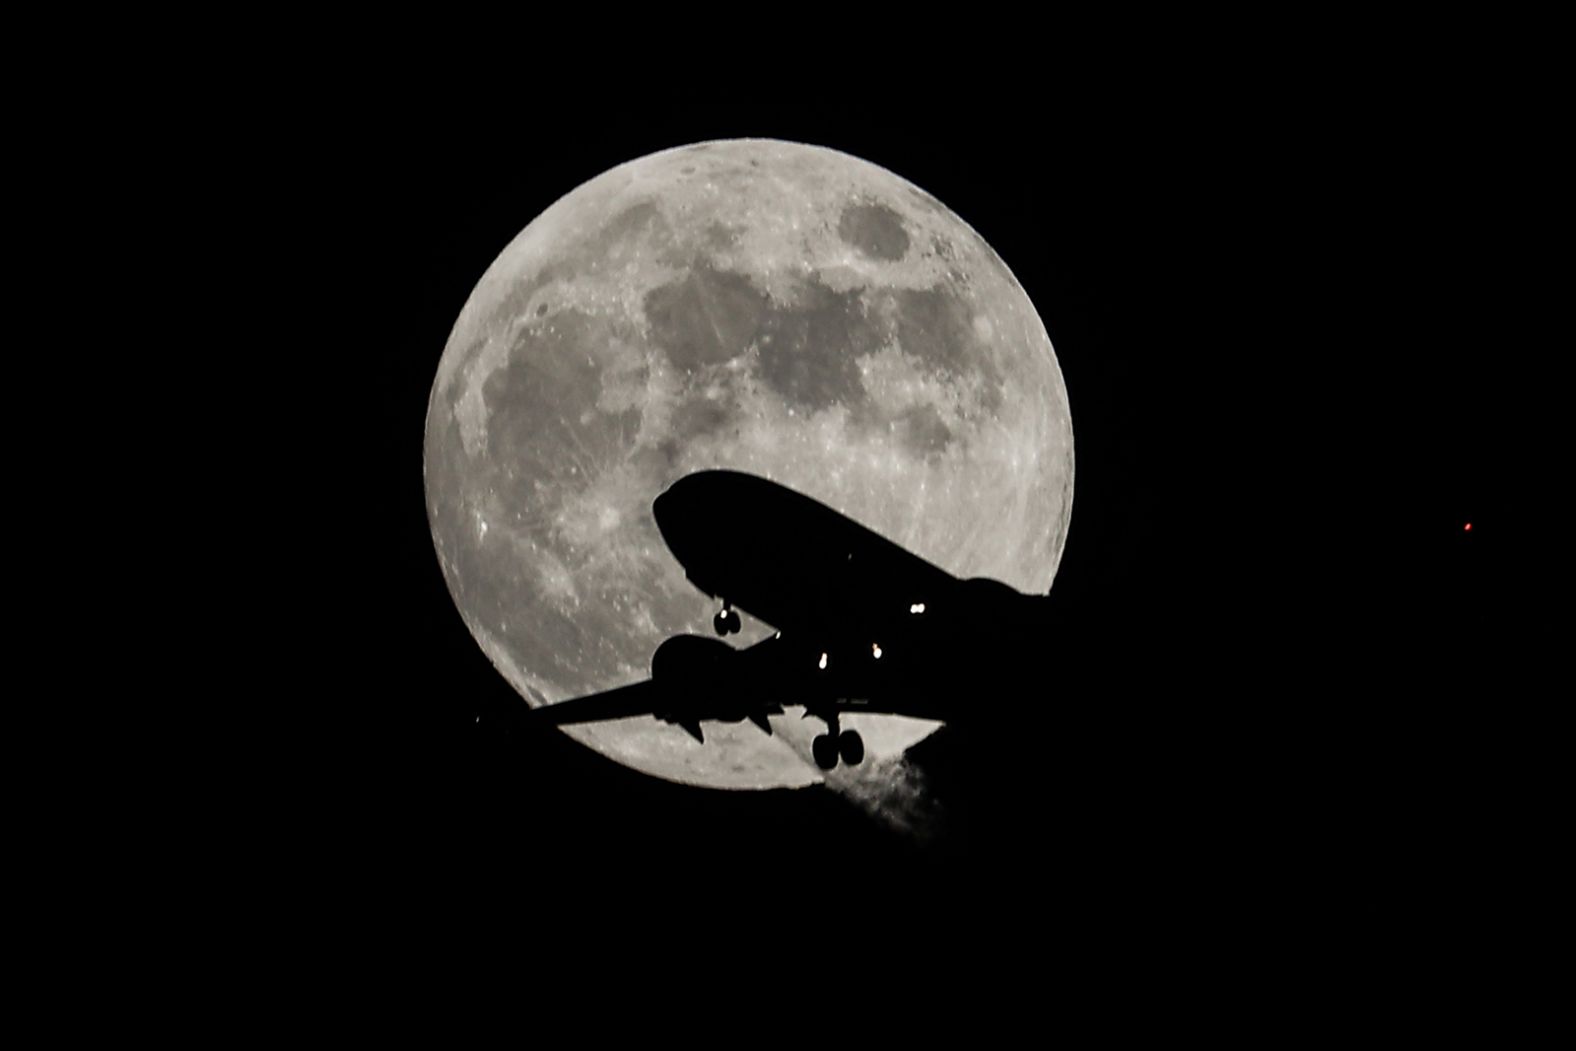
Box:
424 140 1073 788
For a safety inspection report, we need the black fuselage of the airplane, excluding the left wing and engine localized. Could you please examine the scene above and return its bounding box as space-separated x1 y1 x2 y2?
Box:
652 471 1037 720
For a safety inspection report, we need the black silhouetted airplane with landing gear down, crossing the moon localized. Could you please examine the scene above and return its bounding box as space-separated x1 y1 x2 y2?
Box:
525 470 1048 771
